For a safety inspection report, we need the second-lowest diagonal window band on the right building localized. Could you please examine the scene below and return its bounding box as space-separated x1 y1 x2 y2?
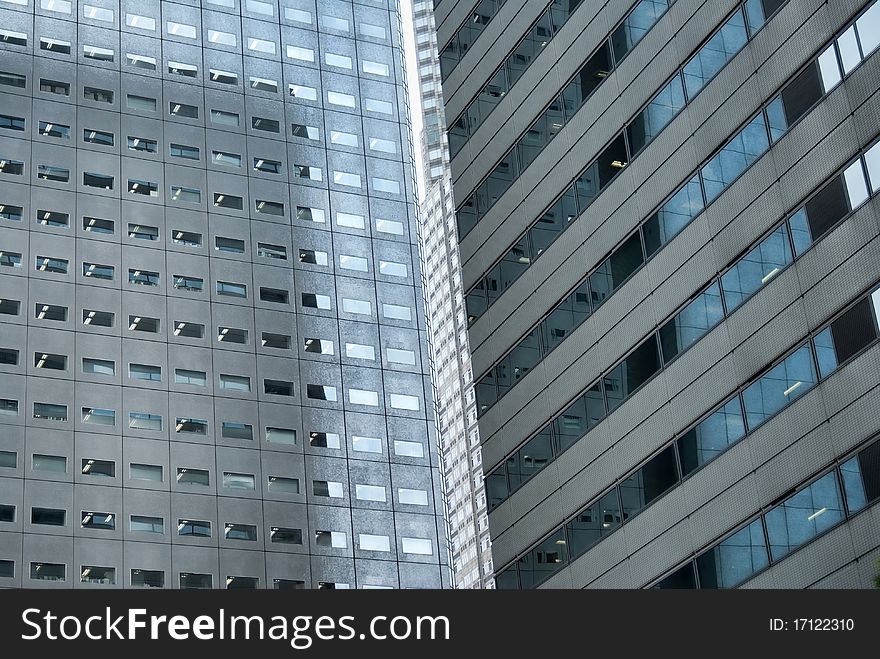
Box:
486 284 880 587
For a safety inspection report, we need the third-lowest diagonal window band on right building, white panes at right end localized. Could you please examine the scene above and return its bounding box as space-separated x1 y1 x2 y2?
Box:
476 143 880 509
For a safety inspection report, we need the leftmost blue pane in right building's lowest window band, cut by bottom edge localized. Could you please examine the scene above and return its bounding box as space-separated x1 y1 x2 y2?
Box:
697 519 770 588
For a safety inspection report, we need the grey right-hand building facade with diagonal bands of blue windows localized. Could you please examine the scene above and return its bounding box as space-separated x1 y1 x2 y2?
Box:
435 0 880 589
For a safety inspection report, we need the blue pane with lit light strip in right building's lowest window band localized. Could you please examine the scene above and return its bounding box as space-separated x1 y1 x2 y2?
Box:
765 471 844 561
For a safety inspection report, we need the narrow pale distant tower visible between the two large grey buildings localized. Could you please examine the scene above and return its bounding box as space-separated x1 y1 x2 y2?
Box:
413 0 494 588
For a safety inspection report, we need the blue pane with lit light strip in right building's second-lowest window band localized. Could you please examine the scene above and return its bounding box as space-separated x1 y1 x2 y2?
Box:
743 343 816 429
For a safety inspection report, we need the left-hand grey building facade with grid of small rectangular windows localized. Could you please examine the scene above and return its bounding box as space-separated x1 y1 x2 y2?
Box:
0 0 448 588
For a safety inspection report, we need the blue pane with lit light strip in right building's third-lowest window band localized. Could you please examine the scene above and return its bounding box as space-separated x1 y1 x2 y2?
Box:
721 224 792 313
